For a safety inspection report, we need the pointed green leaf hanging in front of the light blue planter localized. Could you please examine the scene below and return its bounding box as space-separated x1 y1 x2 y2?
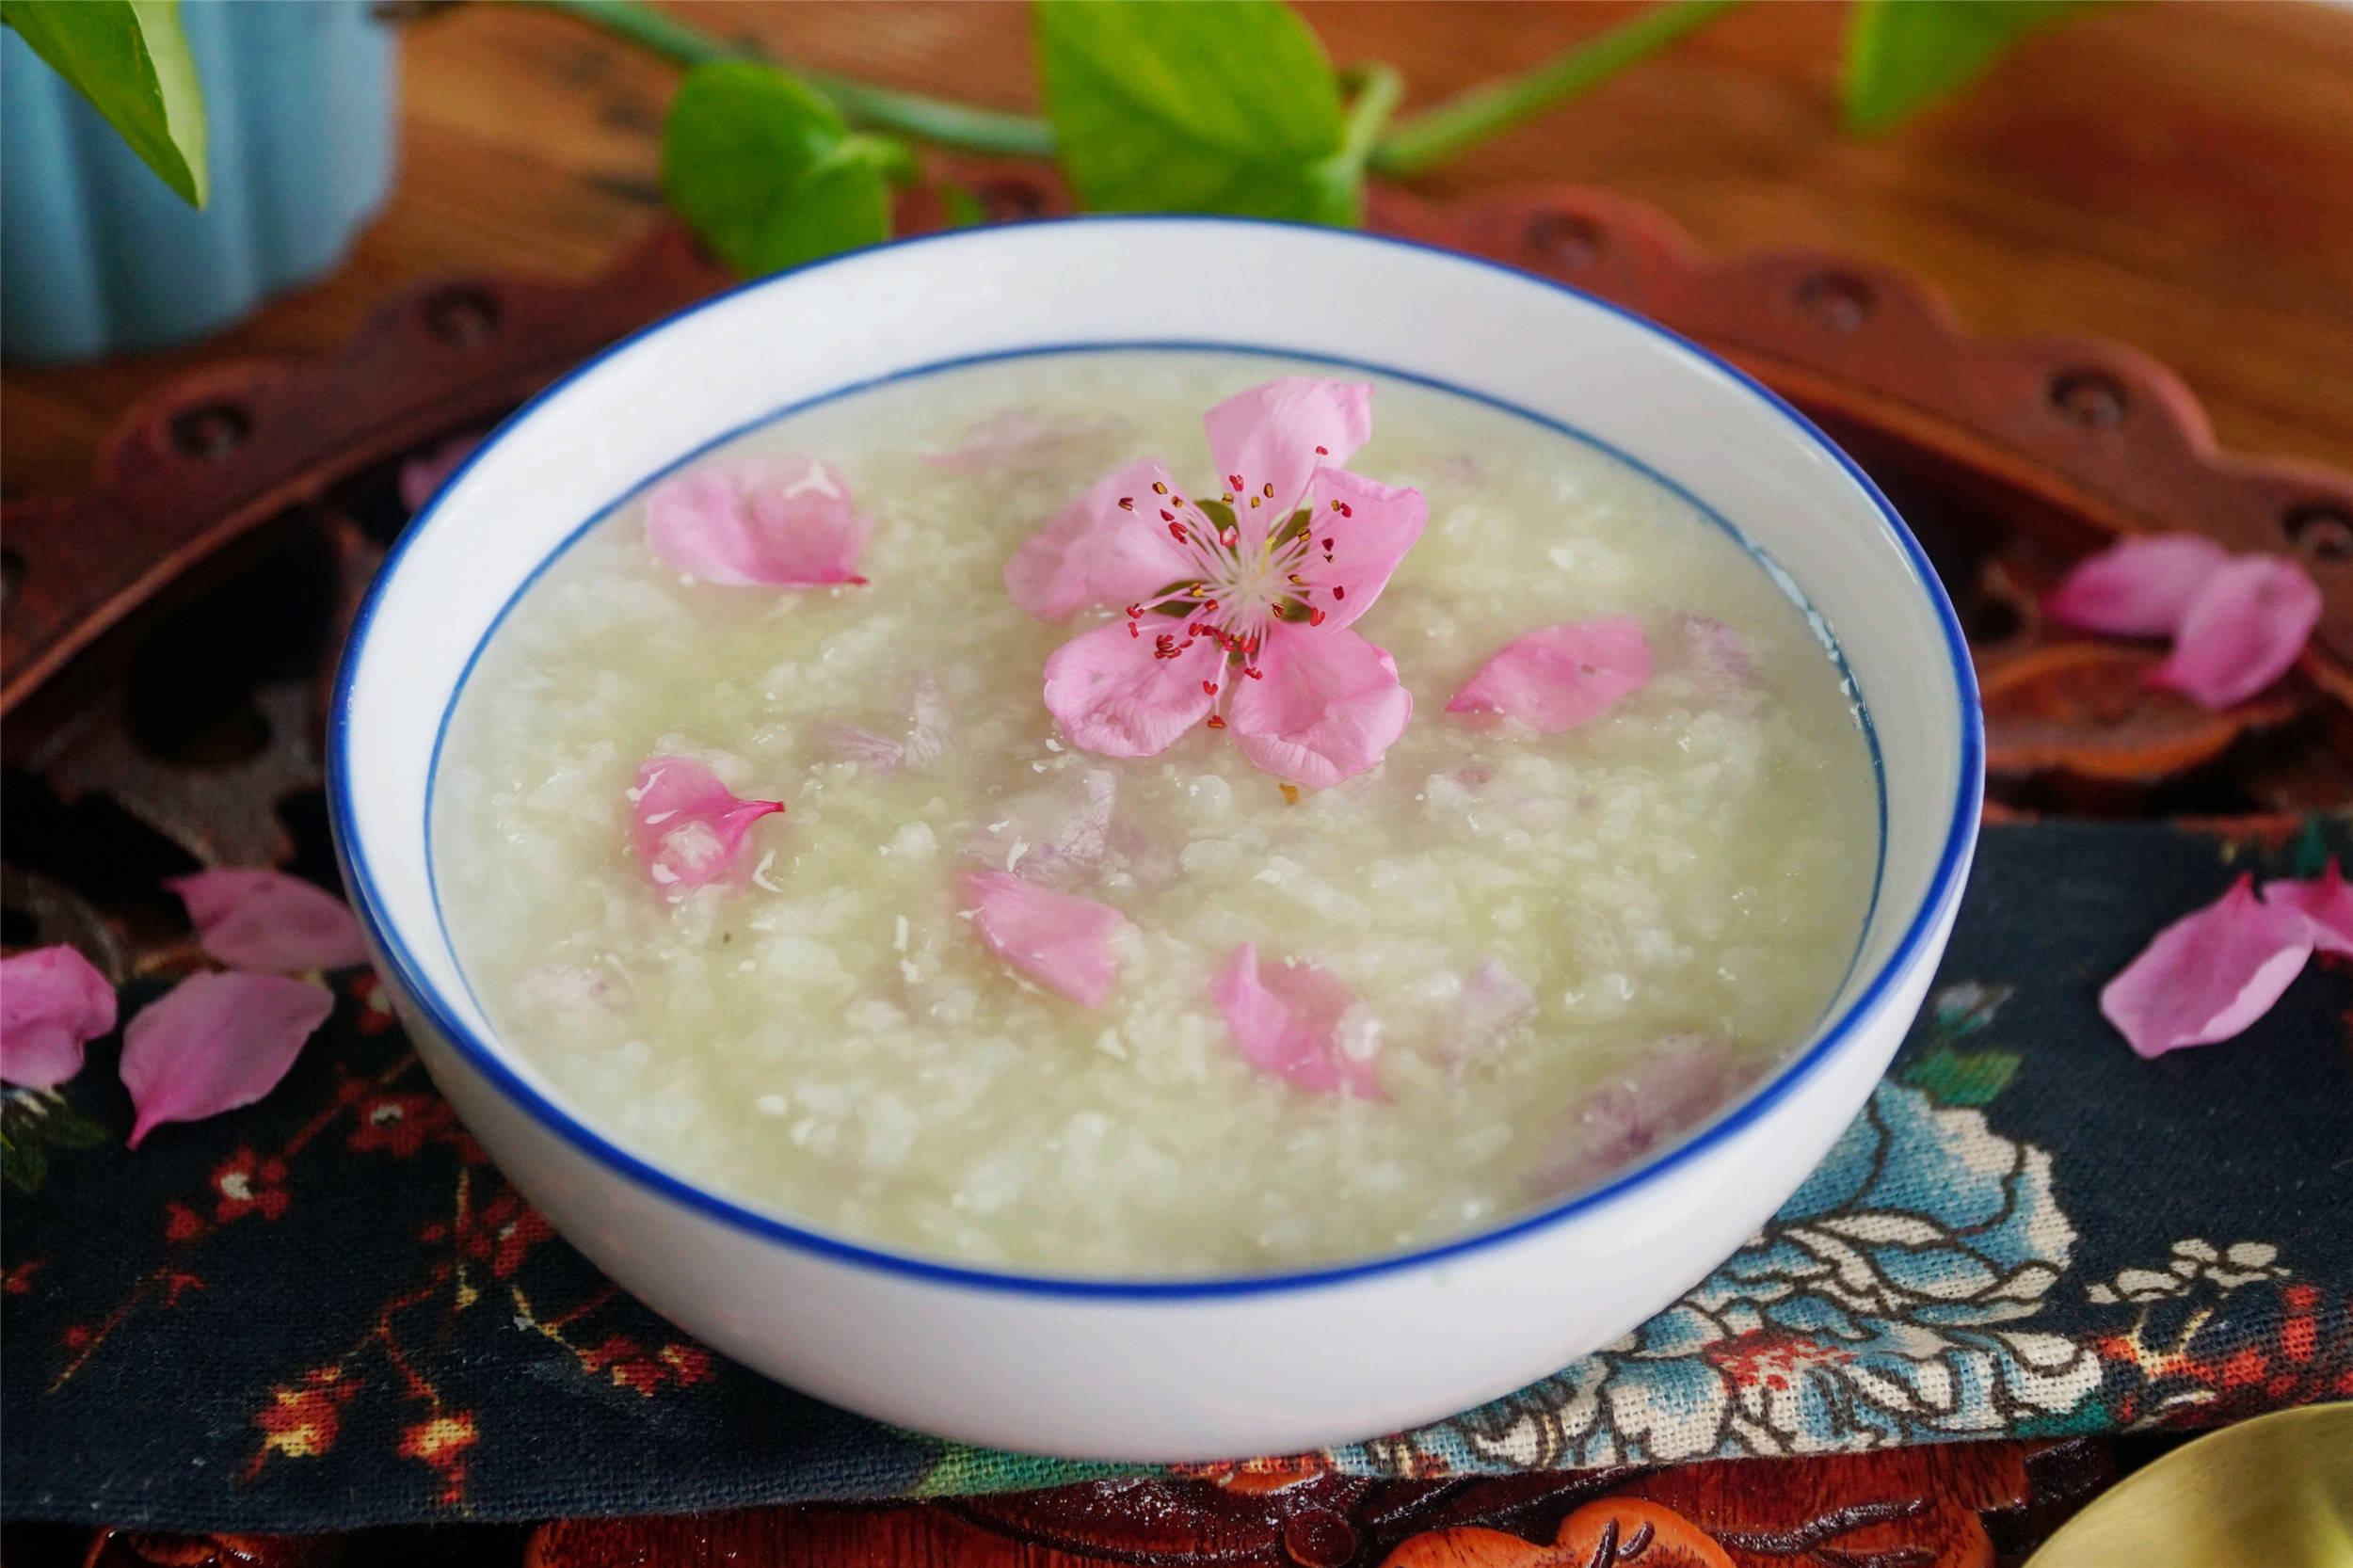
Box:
0 0 212 207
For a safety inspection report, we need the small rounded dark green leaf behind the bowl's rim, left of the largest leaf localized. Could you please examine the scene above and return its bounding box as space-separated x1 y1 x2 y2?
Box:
662 59 908 276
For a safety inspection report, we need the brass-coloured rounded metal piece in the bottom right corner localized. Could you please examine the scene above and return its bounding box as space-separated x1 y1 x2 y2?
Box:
2026 1403 2353 1568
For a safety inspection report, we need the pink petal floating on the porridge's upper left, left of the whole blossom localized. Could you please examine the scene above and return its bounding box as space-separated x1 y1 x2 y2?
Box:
645 452 873 588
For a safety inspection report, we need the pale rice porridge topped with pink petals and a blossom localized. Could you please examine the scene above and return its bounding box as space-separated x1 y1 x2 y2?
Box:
433 351 1878 1278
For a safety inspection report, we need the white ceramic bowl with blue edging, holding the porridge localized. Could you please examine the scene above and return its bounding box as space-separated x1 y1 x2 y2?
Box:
329 219 1981 1460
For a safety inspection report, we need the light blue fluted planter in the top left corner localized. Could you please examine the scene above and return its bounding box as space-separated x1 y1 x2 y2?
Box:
0 0 395 362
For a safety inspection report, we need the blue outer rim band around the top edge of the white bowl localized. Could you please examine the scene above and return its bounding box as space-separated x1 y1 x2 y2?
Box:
328 215 1986 1300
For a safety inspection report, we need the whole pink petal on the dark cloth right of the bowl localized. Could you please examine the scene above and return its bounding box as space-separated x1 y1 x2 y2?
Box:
2099 876 2313 1057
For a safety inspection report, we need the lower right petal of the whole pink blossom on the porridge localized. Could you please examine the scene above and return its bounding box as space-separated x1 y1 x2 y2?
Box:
1226 621 1415 789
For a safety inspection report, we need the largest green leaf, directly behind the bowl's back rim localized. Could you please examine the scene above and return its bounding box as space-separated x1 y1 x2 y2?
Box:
1038 0 1363 224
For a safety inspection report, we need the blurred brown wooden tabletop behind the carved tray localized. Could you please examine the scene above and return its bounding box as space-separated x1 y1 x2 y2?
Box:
0 0 2353 497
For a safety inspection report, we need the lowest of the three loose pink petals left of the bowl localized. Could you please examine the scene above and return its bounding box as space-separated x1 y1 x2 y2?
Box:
122 972 334 1149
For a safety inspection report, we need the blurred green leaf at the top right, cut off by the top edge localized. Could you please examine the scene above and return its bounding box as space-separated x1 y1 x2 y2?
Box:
1843 0 2092 135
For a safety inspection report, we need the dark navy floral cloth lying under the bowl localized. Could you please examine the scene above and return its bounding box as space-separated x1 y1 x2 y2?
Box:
0 822 2353 1530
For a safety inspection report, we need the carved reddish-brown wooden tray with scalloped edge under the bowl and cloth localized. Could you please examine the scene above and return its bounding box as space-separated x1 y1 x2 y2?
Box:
0 165 2353 1568
